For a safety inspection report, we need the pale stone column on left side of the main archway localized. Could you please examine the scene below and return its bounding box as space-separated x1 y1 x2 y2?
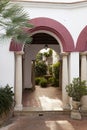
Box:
15 51 24 111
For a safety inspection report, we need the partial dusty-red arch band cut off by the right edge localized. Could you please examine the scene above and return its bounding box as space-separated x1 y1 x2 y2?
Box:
75 26 87 52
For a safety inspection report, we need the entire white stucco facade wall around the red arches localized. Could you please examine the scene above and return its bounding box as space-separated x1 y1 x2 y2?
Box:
0 2 87 86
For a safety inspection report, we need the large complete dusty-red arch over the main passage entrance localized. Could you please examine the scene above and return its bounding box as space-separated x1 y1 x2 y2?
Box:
10 17 74 52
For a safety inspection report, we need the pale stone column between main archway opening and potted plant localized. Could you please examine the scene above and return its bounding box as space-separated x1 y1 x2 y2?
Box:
62 53 70 110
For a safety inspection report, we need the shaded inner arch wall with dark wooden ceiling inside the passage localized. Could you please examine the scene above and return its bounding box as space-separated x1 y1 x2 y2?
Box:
23 33 61 88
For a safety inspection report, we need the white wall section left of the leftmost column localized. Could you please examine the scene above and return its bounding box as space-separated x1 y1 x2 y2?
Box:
0 39 14 87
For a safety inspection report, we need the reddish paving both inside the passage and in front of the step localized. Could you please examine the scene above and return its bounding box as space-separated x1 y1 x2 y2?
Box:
0 87 87 130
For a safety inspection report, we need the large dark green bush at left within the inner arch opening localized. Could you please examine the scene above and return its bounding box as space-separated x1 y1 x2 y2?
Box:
35 61 47 77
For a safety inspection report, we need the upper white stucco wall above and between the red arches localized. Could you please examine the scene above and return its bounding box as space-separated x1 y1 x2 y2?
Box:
16 2 87 45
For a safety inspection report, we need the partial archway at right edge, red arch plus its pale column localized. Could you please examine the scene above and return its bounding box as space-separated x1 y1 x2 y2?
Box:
75 26 87 80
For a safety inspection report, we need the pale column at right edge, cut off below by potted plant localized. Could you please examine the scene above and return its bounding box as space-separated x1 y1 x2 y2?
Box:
81 52 87 80
